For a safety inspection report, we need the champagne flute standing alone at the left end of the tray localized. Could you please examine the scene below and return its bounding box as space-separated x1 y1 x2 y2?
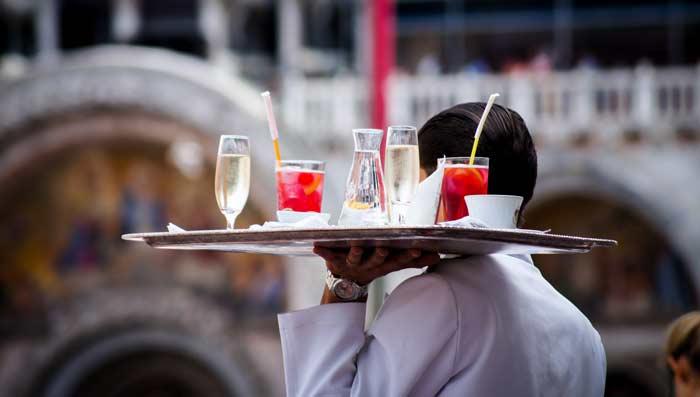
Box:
214 135 250 229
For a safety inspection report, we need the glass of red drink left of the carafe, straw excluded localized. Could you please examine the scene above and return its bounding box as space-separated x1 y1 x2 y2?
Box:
275 160 325 212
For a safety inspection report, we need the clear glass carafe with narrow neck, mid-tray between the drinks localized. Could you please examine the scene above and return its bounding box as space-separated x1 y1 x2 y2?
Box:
338 129 389 226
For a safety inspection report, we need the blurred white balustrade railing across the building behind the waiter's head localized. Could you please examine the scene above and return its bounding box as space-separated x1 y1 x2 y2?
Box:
282 66 700 142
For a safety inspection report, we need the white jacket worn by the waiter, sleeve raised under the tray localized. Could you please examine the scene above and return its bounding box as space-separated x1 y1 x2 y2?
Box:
279 255 606 397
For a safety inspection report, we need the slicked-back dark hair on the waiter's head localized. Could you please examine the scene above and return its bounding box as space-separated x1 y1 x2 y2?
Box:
418 102 537 212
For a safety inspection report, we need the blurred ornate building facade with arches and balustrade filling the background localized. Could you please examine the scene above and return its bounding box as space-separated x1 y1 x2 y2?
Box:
0 0 700 396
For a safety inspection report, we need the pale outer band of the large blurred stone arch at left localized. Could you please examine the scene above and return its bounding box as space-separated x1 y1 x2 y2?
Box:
0 46 314 213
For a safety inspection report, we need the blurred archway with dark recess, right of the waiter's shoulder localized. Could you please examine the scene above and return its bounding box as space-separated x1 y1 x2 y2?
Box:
525 145 700 395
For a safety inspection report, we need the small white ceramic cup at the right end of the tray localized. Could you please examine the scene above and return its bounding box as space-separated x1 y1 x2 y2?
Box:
464 194 523 229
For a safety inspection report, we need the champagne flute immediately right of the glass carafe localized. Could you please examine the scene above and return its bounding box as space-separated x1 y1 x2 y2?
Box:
384 126 420 225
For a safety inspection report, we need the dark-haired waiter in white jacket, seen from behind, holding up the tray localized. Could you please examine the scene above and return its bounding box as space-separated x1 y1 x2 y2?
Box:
279 103 606 397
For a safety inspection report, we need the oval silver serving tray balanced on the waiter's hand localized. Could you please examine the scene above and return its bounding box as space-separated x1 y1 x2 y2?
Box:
122 226 617 256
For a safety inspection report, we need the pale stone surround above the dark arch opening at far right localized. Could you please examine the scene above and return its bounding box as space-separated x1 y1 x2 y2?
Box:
526 146 700 280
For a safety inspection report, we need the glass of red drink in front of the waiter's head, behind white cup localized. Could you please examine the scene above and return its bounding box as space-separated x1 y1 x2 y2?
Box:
438 157 489 221
